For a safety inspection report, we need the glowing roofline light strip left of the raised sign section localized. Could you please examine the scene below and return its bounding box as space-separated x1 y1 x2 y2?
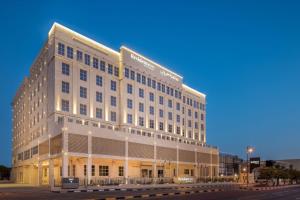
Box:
48 22 120 56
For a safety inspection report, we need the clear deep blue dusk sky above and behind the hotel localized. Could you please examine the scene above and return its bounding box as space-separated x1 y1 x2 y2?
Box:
0 0 300 165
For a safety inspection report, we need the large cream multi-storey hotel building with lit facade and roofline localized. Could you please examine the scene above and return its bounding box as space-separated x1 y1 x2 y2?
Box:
12 23 219 185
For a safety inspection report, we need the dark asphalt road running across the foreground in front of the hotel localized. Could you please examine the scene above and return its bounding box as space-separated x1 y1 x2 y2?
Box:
0 186 300 200
